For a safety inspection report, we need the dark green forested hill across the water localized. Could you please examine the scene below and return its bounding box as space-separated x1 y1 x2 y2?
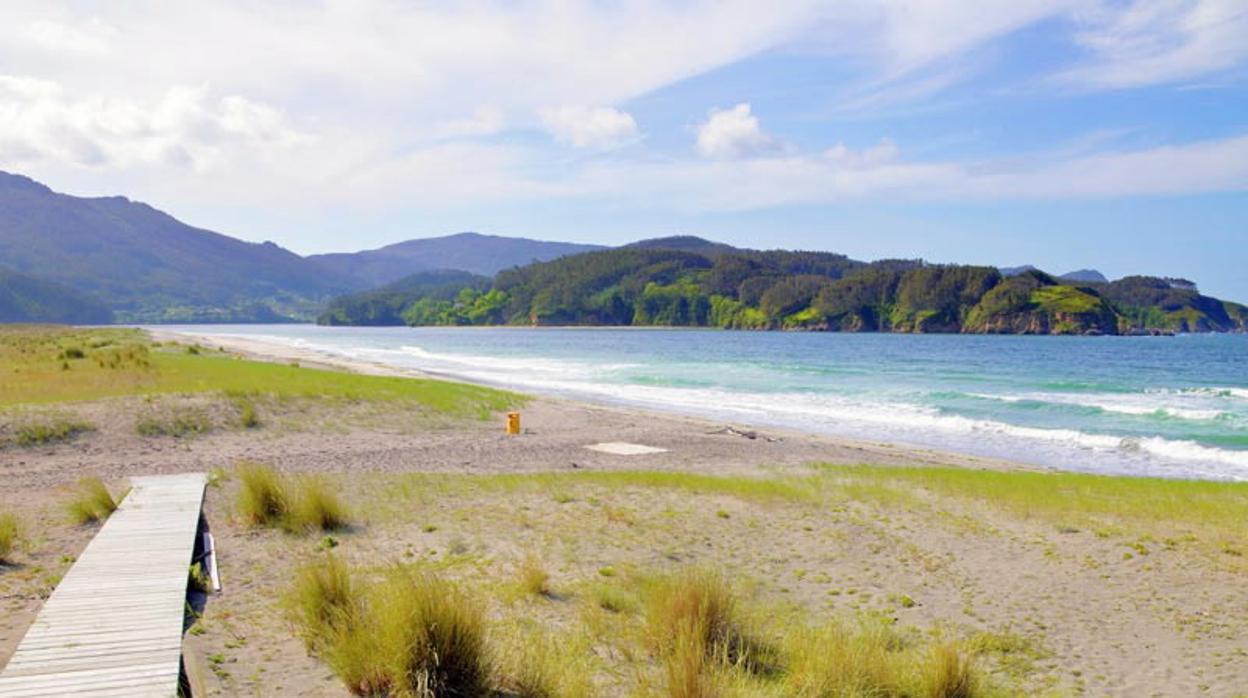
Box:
322 237 1248 335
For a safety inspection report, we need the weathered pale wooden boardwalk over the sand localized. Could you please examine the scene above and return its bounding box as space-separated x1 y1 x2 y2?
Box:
0 473 205 698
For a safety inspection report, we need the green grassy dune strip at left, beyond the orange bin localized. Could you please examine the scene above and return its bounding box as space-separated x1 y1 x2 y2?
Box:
0 326 524 421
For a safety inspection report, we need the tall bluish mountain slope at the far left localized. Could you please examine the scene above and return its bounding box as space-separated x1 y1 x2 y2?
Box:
0 172 358 322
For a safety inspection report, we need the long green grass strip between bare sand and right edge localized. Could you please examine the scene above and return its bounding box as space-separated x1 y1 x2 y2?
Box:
378 465 1248 563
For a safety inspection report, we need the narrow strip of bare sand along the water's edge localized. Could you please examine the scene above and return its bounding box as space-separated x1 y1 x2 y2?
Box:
153 327 1067 472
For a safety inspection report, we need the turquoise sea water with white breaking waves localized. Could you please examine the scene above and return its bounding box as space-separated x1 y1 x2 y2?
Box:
165 325 1248 481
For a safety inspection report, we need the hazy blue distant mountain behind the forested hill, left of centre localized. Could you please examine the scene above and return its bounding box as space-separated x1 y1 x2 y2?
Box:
307 232 605 288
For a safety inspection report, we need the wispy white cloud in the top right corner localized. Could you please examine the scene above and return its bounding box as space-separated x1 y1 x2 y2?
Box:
1061 0 1248 87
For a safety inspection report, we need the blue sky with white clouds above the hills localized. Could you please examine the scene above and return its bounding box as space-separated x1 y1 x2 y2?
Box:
0 0 1248 301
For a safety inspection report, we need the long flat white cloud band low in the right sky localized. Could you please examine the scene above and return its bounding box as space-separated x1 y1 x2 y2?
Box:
574 135 1248 212
